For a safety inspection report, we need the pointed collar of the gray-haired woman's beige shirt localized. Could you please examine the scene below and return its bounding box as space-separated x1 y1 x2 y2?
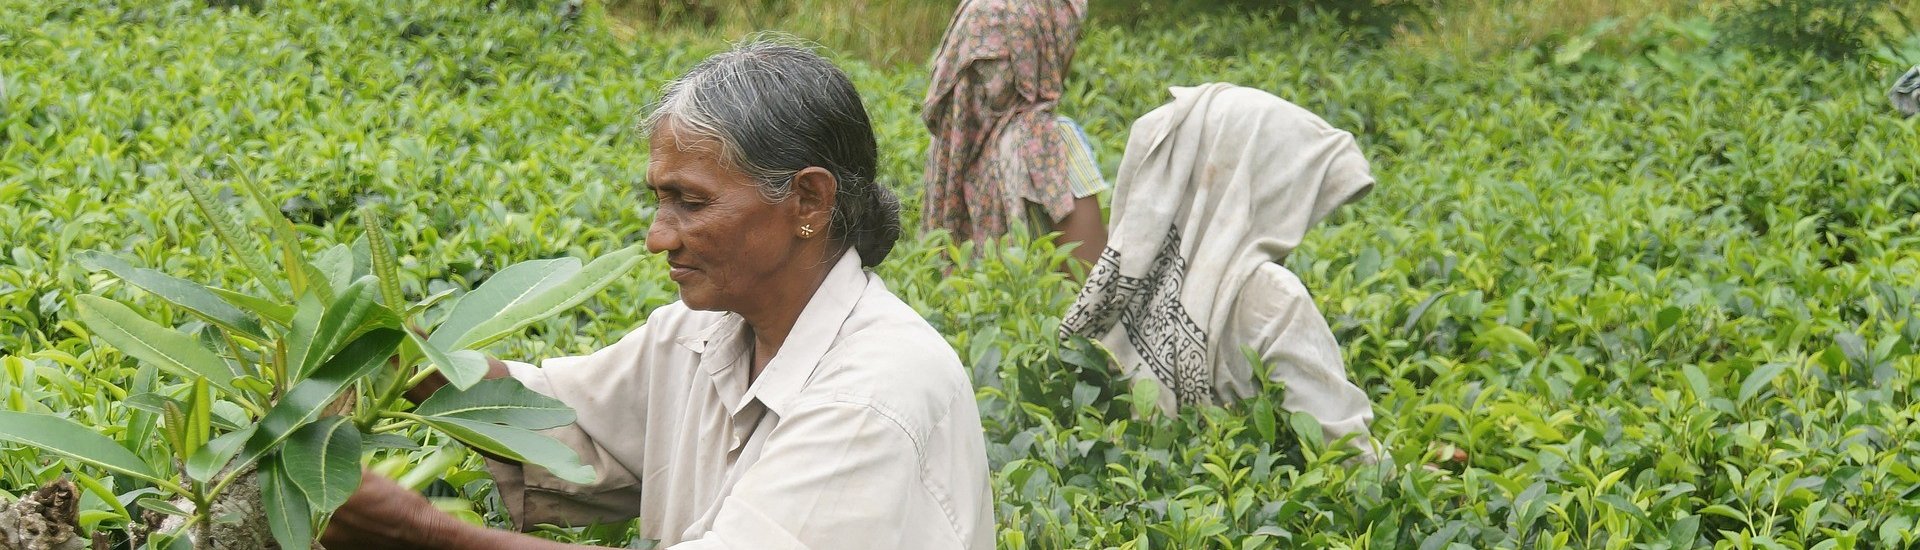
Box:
678 250 868 413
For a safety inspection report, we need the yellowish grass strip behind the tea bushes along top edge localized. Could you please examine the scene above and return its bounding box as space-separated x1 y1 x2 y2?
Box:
607 0 1920 67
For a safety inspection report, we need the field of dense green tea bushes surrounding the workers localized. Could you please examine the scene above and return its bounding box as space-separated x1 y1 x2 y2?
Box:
0 0 1920 548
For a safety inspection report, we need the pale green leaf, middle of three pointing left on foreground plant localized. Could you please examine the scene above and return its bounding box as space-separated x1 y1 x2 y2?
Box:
75 294 238 394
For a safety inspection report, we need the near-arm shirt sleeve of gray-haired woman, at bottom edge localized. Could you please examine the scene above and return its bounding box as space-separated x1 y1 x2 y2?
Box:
670 402 925 550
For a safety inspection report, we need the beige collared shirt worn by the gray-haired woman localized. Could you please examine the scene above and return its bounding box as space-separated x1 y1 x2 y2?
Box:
492 250 995 550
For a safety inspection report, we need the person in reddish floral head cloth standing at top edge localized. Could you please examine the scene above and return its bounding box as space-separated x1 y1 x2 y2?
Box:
922 0 1106 263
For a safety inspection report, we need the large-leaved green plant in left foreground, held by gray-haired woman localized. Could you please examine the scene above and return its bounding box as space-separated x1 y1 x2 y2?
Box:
0 174 641 548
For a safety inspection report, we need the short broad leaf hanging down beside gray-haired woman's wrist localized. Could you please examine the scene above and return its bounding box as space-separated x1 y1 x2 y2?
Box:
280 415 361 512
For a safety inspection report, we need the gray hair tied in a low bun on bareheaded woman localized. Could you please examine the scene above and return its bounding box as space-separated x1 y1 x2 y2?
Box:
641 38 900 267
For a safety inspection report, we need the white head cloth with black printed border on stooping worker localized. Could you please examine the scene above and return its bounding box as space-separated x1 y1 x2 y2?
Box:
1060 83 1373 404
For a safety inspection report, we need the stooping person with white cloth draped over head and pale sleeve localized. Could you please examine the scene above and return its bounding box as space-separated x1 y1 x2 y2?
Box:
1060 83 1373 448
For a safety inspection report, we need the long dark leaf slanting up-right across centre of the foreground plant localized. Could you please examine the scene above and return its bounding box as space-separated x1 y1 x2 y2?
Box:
234 329 401 475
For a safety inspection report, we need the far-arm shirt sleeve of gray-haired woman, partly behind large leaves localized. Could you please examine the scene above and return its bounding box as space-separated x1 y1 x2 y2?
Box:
488 325 647 531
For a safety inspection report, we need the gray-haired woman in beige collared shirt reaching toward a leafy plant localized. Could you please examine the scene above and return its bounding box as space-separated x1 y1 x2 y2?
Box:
323 42 995 550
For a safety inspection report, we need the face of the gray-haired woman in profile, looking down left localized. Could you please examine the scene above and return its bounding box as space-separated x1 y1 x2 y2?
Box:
647 121 803 313
